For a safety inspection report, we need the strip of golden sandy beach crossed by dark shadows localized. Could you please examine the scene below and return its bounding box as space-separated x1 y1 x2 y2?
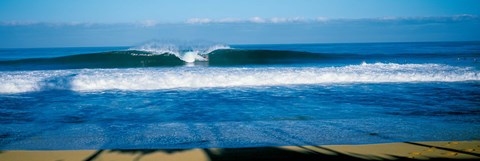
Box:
0 141 480 161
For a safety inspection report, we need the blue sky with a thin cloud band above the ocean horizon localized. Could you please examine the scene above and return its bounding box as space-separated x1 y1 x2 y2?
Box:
0 0 480 48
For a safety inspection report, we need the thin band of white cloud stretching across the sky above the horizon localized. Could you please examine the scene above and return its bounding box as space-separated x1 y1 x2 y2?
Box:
0 14 480 27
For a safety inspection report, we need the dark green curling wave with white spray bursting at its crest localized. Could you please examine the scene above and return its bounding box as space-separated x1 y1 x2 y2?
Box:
0 46 334 70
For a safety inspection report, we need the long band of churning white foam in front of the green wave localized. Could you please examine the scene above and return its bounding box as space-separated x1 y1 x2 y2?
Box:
0 63 480 93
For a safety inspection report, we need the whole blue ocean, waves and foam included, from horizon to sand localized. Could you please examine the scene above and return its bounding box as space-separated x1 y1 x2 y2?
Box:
0 42 480 150
